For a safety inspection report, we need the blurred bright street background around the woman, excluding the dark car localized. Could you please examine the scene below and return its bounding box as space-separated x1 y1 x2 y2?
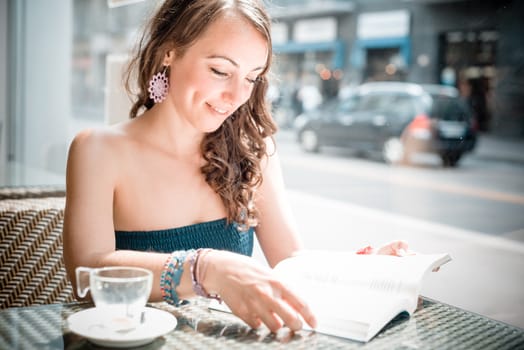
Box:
0 0 524 328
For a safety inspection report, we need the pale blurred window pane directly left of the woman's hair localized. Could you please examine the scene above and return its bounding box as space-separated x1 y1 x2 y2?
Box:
71 0 154 121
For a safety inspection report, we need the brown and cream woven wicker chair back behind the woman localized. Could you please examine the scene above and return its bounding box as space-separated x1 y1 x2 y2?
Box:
0 197 74 309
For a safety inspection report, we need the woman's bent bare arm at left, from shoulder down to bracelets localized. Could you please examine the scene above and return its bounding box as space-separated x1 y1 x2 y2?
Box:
63 130 172 301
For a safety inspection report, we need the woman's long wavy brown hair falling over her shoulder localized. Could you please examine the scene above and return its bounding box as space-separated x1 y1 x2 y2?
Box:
126 0 277 230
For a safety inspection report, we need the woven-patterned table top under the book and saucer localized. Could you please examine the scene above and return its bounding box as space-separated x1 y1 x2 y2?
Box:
0 297 524 350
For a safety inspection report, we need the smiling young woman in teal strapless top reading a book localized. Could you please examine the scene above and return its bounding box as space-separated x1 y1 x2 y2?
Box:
64 0 405 331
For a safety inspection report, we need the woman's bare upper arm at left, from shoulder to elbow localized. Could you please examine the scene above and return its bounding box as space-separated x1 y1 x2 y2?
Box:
63 130 117 289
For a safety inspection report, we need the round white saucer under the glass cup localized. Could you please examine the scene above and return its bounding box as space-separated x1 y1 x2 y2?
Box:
67 307 177 348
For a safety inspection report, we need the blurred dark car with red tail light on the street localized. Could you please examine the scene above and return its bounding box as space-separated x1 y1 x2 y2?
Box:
294 82 476 166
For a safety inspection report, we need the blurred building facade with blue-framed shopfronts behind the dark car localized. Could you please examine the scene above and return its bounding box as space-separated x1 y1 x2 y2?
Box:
271 0 524 137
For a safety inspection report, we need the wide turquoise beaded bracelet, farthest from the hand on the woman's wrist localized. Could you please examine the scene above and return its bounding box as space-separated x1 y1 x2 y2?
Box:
160 250 195 305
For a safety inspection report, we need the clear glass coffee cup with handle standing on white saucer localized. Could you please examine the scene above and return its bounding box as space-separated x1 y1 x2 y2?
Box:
75 266 153 331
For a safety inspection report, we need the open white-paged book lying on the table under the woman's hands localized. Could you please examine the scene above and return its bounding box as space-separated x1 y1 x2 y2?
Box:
210 251 451 342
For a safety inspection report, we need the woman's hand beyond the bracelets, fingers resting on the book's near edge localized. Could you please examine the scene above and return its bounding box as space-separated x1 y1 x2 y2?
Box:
201 250 316 332
